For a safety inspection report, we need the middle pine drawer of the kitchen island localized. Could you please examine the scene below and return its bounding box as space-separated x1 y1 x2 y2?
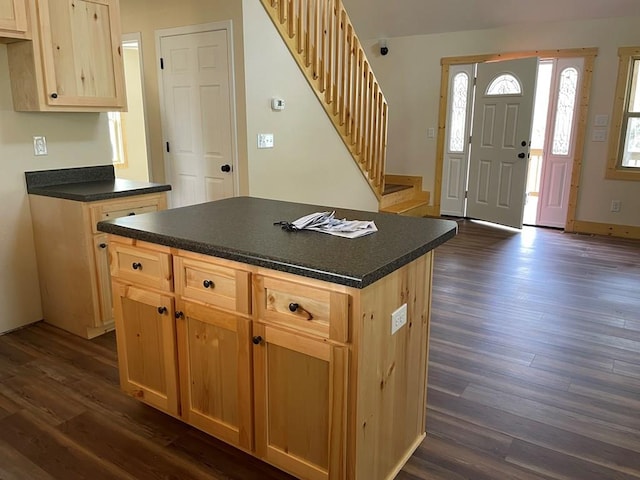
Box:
174 255 251 314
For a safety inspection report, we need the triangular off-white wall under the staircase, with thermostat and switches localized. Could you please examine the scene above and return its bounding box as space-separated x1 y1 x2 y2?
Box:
242 0 378 211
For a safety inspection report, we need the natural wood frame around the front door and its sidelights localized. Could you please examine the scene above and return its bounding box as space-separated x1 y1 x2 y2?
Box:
430 48 598 232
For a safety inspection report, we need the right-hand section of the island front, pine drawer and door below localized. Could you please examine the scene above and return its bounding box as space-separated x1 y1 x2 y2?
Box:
253 272 349 480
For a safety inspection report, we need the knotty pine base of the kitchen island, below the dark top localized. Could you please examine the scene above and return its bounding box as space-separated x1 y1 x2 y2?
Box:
110 236 433 480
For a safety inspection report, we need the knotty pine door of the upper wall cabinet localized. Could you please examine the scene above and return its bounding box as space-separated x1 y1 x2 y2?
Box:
37 0 125 109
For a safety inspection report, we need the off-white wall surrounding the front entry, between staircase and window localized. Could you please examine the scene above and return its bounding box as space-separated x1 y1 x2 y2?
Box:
362 17 640 226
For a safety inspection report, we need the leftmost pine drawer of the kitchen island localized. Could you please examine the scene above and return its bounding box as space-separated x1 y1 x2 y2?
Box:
109 241 173 292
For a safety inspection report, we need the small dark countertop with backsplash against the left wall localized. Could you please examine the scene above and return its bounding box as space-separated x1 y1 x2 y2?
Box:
25 165 171 202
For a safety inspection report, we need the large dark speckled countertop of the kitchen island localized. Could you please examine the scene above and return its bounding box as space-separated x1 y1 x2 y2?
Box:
98 197 457 288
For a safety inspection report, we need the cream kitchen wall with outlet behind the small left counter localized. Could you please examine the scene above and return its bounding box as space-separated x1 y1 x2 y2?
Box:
0 44 111 333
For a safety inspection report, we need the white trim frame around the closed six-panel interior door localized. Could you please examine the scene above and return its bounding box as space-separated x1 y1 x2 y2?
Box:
155 20 240 203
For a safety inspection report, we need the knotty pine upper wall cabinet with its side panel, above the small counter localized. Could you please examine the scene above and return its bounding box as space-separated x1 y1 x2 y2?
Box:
5 0 126 112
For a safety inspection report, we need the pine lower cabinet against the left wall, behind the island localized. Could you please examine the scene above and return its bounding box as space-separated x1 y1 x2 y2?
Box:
29 193 167 338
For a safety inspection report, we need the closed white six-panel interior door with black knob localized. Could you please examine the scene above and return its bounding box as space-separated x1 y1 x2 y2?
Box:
159 29 235 207
